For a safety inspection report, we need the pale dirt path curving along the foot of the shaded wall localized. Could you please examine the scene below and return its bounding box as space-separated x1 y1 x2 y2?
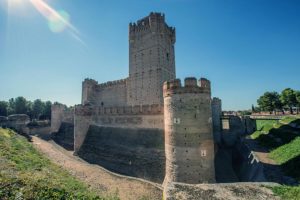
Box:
33 137 162 200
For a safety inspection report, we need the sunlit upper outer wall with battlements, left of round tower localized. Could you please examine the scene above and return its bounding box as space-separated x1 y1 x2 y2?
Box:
74 104 164 152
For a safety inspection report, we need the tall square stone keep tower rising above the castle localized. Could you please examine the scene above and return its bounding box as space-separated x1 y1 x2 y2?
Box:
127 13 176 105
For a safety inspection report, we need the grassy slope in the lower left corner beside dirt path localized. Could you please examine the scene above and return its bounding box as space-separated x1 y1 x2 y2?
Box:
0 128 118 199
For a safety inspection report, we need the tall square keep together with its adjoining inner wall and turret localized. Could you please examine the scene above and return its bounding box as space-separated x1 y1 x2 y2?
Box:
82 13 176 107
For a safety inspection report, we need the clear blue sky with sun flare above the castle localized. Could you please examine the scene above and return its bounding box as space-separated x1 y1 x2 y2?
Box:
0 0 300 110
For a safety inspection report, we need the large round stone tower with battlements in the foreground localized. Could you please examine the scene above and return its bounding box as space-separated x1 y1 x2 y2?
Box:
163 78 215 185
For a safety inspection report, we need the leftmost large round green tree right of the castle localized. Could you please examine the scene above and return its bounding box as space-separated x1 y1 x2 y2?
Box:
257 92 282 113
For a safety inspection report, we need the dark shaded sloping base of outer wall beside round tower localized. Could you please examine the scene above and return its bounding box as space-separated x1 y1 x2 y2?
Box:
78 126 165 183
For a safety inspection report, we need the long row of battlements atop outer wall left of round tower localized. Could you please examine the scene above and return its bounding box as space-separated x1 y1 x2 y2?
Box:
75 104 164 116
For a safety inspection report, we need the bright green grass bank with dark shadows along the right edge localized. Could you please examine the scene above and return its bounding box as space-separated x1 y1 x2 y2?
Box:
251 117 300 200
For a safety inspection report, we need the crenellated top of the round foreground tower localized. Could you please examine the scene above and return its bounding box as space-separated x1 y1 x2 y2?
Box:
163 77 211 97
